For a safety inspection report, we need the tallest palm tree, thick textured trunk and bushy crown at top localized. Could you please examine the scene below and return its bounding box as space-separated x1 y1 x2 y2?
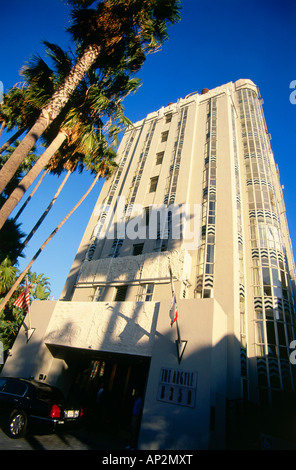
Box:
0 0 179 195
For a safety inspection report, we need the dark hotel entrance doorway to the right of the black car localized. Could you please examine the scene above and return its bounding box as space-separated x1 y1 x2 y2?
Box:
67 354 150 434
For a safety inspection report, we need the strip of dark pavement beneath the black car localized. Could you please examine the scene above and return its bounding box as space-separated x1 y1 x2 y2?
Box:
0 429 125 451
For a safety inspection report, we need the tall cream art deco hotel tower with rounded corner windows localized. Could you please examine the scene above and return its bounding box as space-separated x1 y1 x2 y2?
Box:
6 79 296 449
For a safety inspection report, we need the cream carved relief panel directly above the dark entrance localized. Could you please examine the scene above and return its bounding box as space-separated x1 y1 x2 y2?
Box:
45 302 159 356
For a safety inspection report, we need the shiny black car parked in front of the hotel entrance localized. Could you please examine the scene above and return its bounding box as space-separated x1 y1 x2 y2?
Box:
0 377 83 439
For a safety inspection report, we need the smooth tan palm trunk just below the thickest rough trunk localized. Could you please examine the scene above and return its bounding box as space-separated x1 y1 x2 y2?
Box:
0 131 67 229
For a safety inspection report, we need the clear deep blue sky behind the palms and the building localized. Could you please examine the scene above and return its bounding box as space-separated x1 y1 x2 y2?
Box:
0 0 296 298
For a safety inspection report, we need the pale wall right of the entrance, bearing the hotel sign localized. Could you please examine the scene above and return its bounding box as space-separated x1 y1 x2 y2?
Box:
139 299 227 450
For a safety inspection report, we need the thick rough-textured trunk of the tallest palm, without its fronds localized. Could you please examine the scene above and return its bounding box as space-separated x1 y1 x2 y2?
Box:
0 45 100 193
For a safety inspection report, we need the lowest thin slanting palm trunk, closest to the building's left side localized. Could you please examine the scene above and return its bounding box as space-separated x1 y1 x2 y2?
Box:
0 173 100 312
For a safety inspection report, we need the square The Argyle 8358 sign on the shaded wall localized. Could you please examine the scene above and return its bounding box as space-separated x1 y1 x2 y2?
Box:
157 367 197 408
